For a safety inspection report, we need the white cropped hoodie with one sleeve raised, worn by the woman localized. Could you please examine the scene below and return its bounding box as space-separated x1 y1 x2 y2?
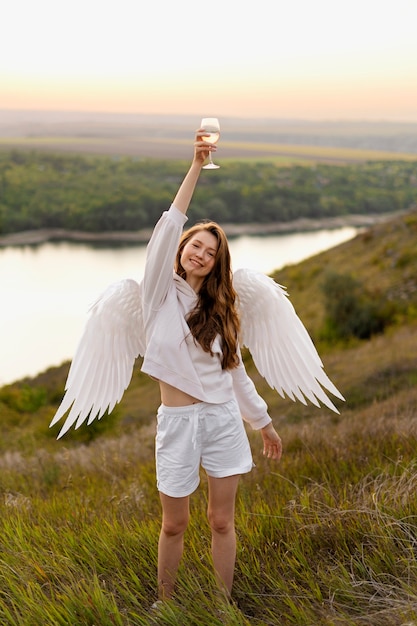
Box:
141 205 271 430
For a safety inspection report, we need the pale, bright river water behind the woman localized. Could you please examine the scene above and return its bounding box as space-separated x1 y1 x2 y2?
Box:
0 227 357 385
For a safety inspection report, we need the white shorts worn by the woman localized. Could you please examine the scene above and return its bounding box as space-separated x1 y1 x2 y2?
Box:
155 400 253 498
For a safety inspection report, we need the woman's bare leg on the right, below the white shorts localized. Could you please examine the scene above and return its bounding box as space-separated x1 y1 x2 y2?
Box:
207 475 240 596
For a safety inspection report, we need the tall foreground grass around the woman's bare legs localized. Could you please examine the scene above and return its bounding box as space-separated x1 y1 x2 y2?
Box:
0 376 417 626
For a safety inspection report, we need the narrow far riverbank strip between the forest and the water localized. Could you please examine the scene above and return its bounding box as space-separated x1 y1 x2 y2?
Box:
0 212 404 248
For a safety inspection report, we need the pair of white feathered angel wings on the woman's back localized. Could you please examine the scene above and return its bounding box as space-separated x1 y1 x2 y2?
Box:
50 269 344 439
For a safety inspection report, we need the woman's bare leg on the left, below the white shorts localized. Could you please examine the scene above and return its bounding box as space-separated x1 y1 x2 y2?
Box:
158 493 189 600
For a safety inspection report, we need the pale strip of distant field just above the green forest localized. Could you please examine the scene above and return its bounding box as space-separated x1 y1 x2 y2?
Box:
0 136 417 164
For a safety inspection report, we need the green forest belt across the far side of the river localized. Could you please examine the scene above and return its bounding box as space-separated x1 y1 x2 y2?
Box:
0 150 417 235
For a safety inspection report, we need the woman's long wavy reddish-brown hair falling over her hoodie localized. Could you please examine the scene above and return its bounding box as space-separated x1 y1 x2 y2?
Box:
175 221 240 369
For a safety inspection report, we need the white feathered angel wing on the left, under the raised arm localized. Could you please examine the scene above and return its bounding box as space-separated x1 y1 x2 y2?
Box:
50 279 145 439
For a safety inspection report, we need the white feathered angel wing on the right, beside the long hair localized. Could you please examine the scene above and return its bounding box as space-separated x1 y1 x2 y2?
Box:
233 269 344 413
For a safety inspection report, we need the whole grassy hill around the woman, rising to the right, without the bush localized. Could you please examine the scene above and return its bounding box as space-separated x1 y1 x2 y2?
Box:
0 207 417 626
